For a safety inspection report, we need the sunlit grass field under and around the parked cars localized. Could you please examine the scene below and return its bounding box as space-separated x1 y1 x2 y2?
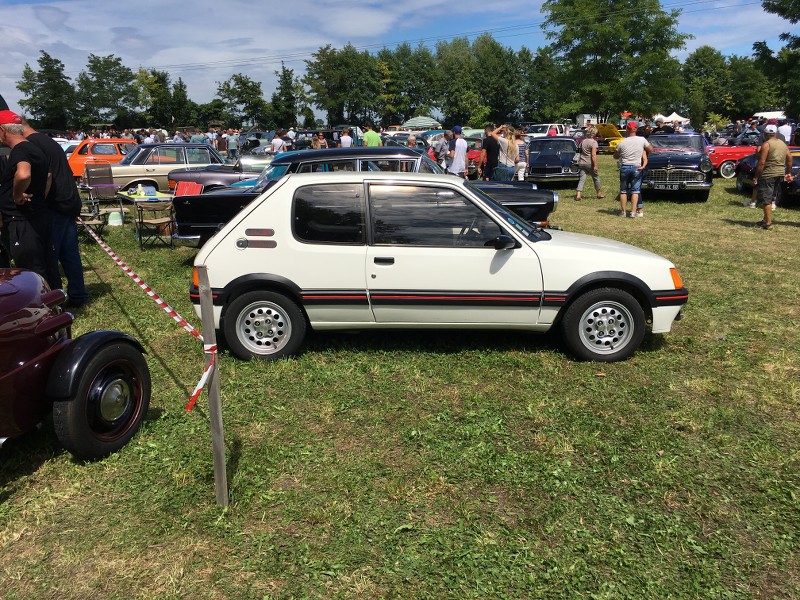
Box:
0 157 800 599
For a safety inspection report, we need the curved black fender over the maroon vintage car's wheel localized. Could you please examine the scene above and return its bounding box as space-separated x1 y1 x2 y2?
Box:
45 330 145 400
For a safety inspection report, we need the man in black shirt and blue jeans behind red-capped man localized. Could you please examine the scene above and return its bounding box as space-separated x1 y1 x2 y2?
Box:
23 121 89 307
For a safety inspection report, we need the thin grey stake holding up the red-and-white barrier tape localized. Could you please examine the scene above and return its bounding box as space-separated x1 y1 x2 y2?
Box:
197 265 228 506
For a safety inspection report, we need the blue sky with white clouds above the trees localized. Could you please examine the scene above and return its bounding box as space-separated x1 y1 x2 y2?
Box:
0 0 793 110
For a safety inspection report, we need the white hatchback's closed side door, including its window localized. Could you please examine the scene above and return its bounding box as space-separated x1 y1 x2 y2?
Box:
366 183 542 327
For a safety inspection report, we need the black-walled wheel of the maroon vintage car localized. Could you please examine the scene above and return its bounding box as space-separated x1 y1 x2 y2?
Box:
53 342 150 460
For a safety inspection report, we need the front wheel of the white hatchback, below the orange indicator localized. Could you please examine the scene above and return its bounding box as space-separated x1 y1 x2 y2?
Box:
561 288 645 362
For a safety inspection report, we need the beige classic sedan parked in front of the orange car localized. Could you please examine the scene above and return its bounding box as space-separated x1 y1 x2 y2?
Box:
111 143 225 192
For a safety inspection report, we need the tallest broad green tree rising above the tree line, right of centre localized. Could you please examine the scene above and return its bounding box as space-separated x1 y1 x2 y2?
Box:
542 0 690 114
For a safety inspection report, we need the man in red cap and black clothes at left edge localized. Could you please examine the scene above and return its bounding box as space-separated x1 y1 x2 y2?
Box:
0 110 61 288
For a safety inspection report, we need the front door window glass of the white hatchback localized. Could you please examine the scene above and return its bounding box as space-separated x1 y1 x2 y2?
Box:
369 184 502 247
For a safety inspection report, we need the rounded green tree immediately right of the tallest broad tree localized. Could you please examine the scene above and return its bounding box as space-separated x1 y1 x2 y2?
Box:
683 46 733 124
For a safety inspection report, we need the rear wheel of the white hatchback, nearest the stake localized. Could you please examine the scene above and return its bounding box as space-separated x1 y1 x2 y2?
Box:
223 291 306 360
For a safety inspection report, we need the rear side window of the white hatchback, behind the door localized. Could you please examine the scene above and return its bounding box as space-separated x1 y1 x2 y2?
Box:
292 184 365 244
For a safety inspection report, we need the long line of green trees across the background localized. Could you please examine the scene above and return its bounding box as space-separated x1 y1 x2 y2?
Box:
17 0 800 129
